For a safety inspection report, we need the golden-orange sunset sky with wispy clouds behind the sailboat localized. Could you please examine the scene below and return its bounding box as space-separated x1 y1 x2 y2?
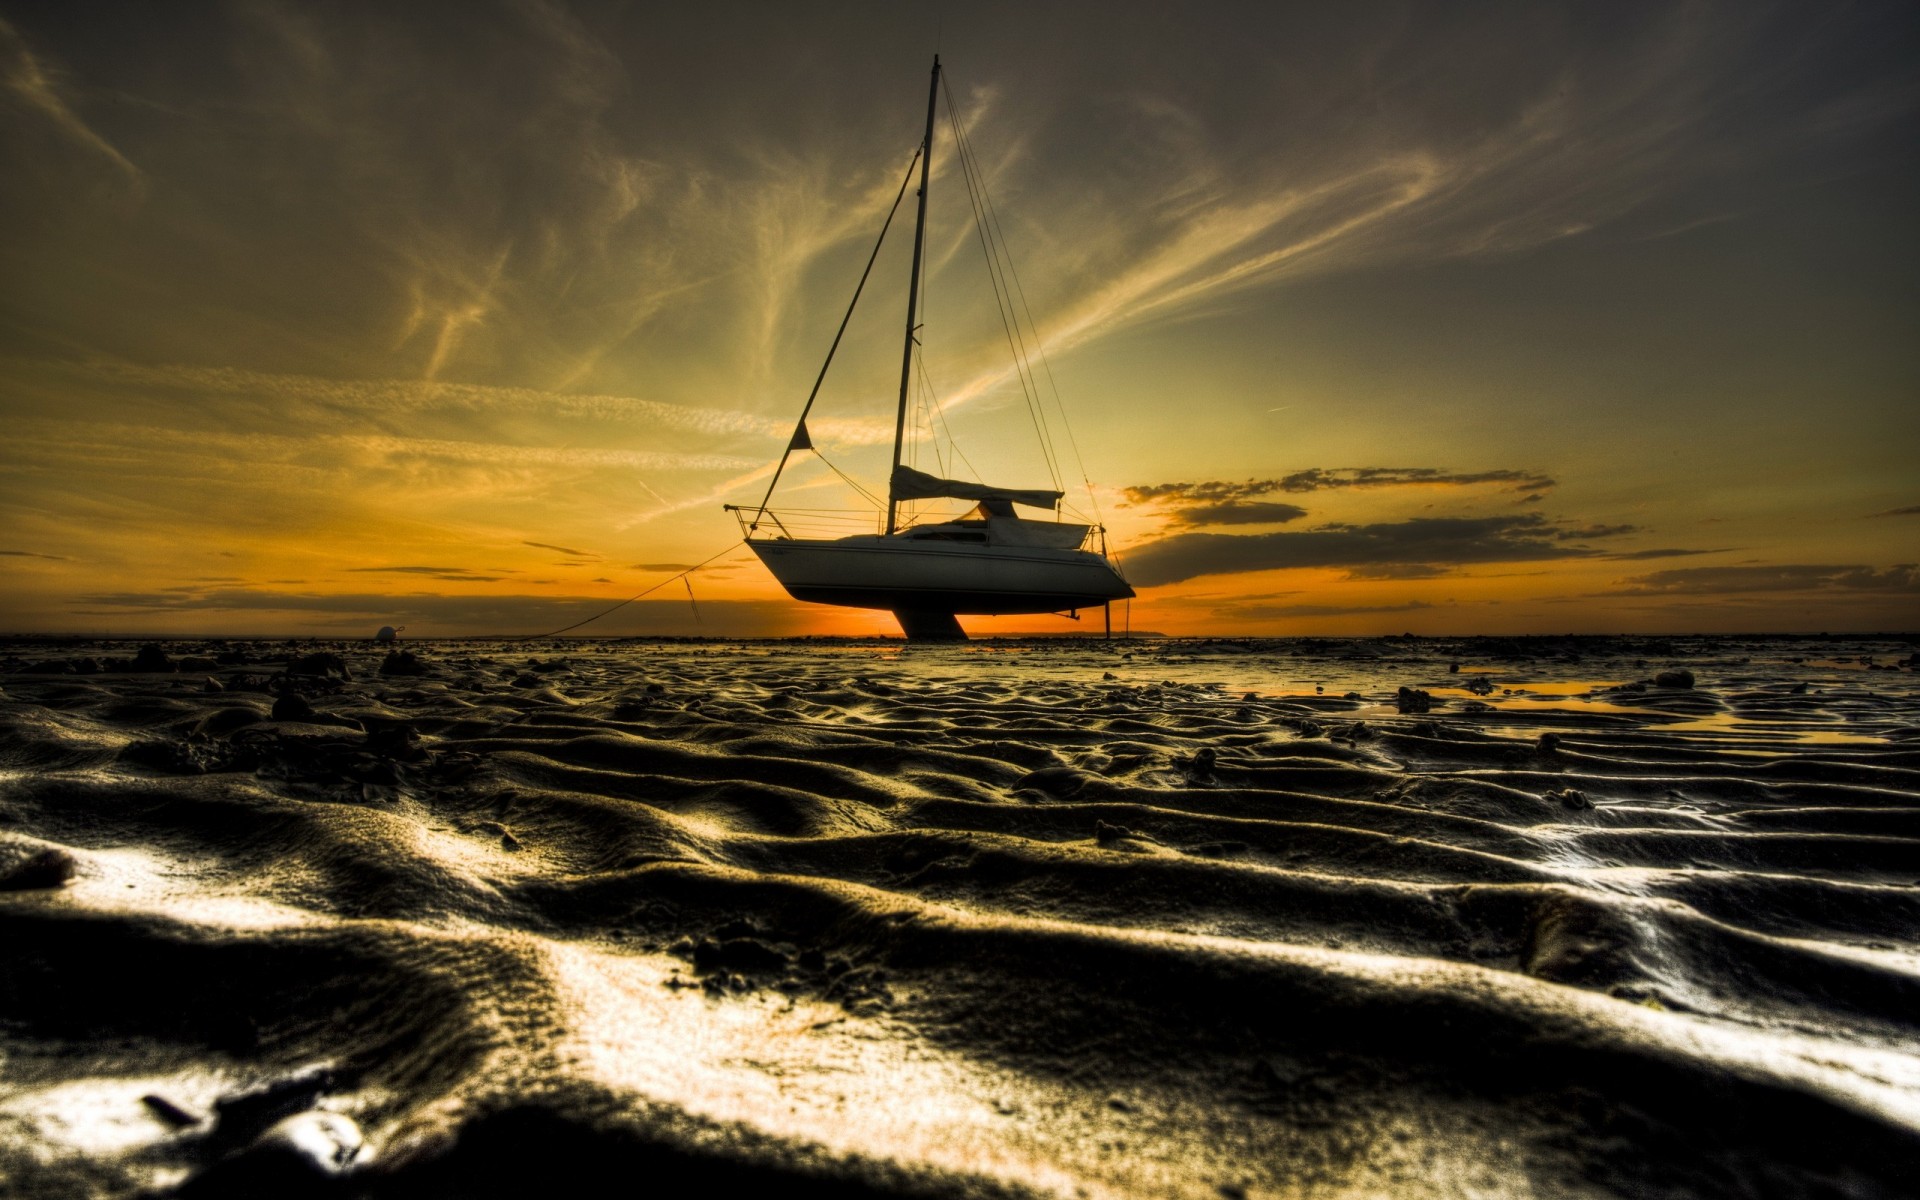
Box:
0 0 1920 636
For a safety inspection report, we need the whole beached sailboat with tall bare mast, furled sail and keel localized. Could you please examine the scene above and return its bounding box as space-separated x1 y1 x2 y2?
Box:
726 56 1133 641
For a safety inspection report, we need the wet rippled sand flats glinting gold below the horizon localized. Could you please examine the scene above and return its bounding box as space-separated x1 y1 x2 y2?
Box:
0 639 1920 1198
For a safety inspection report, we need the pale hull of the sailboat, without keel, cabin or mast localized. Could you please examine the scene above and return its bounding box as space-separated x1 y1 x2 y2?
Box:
747 534 1133 616
